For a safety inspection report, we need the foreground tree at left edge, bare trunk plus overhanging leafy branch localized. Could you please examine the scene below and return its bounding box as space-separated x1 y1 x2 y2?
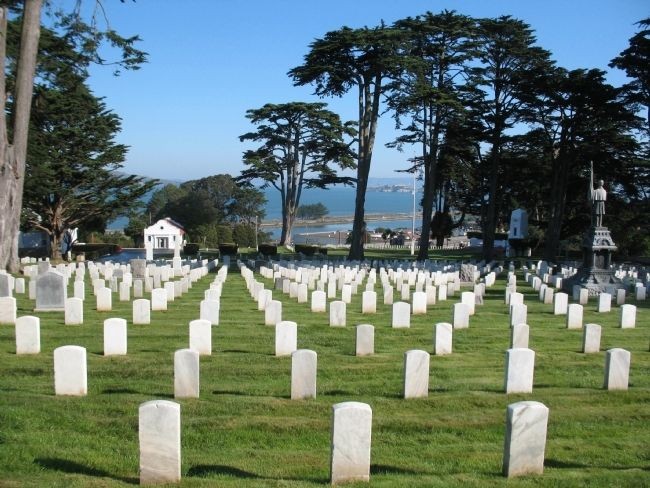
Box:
0 0 146 271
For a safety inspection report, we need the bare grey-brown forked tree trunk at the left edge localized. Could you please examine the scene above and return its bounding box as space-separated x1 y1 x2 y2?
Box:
0 0 43 272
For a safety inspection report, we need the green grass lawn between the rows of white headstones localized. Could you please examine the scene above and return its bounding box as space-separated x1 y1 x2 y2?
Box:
0 264 650 487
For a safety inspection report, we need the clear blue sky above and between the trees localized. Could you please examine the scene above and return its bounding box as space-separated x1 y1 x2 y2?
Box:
52 0 650 180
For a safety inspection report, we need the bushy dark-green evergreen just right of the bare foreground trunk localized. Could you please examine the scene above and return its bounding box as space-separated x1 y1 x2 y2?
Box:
22 81 155 258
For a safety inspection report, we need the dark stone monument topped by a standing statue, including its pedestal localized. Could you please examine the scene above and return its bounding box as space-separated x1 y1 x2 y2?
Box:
562 162 623 296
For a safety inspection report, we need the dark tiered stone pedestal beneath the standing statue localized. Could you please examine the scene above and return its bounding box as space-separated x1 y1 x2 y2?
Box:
562 226 623 296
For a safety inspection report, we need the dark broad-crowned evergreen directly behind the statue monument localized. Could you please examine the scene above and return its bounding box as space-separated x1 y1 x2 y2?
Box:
521 68 638 260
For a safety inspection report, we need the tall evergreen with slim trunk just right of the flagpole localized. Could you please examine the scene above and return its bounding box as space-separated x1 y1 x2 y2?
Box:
389 11 475 260
